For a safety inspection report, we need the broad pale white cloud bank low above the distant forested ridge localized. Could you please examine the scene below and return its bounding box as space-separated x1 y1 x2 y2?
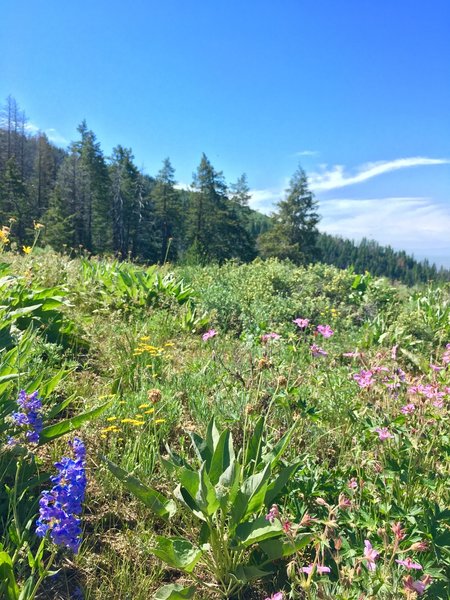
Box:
320 197 450 266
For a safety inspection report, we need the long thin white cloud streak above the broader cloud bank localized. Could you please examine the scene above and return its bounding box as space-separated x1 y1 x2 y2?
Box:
308 156 450 191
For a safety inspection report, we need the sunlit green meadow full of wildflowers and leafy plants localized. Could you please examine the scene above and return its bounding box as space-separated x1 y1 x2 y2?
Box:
0 252 450 600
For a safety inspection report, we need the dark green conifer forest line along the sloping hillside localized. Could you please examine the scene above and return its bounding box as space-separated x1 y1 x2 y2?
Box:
0 96 450 284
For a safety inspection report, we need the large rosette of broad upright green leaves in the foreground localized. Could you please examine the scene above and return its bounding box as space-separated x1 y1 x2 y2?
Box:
104 417 311 600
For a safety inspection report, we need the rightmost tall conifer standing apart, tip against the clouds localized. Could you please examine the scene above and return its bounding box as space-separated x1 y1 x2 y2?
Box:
258 167 320 264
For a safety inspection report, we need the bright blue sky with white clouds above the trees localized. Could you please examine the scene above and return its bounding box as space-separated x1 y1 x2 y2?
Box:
0 0 450 266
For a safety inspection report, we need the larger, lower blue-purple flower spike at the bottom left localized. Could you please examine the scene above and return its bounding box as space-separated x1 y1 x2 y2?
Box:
36 438 86 553
